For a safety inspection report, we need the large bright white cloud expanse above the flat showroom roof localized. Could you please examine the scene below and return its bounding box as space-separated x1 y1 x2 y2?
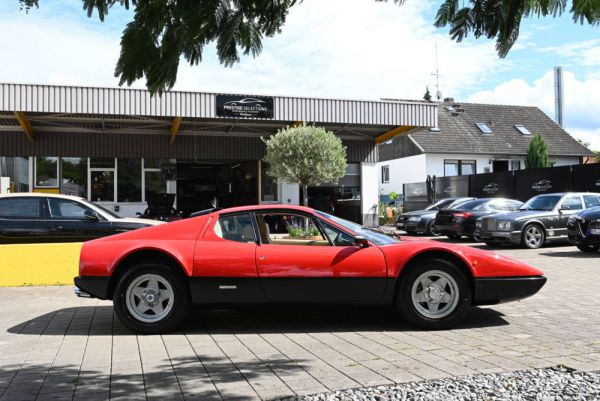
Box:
0 0 510 99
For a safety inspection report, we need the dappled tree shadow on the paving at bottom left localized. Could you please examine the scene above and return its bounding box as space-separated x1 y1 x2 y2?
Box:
0 354 307 401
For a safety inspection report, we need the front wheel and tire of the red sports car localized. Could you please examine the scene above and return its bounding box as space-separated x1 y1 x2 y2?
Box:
396 258 472 330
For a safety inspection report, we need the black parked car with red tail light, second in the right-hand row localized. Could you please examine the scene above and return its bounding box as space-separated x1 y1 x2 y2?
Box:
435 198 523 239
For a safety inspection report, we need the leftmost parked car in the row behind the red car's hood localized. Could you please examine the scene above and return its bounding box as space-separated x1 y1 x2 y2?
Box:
396 198 474 236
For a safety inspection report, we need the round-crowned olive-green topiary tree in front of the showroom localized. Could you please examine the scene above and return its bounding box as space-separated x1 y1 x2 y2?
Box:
264 125 346 206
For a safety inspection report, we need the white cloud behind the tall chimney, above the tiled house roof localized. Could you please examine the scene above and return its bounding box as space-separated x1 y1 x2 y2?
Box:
467 70 600 149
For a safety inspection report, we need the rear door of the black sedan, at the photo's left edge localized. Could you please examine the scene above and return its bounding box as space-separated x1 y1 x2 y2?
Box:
0 196 48 244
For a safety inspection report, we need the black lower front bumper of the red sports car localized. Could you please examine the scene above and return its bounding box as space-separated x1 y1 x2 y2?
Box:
473 276 547 305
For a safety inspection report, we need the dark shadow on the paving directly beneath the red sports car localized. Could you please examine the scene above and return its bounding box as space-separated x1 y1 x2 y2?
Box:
7 305 508 336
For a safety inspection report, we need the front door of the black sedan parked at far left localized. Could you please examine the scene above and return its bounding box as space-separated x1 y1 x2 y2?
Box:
47 197 115 242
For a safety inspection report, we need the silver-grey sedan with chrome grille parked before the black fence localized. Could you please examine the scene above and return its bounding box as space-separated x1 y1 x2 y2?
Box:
476 192 600 249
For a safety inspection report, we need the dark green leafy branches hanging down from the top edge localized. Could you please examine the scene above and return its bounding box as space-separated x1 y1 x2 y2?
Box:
18 0 600 93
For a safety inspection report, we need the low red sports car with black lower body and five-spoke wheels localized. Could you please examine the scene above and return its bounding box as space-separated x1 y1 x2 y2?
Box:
75 205 546 333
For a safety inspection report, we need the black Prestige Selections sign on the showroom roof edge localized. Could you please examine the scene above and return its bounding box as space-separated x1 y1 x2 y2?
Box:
217 95 273 118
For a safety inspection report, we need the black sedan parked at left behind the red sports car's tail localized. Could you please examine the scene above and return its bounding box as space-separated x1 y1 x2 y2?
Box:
0 193 162 244
